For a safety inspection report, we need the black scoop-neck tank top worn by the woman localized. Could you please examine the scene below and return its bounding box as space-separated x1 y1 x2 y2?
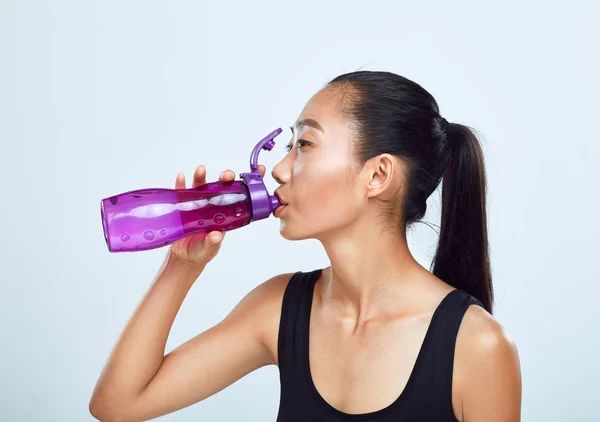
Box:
277 269 483 422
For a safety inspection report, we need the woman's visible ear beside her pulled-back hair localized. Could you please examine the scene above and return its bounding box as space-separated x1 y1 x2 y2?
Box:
365 154 400 200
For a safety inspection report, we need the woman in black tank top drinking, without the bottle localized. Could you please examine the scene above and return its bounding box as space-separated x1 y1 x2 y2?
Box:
90 71 521 422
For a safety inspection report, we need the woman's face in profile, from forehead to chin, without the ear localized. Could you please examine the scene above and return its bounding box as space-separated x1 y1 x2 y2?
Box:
272 88 366 240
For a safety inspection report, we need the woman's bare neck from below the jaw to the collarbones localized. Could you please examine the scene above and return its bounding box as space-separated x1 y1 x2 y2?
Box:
319 218 429 324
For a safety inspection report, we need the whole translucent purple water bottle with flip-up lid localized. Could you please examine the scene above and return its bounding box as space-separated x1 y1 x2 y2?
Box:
100 128 281 252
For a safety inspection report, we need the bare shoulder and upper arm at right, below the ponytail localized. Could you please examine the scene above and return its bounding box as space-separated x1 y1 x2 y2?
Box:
453 305 521 421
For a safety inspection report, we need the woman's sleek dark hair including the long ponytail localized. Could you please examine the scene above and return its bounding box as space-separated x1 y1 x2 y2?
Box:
327 71 493 313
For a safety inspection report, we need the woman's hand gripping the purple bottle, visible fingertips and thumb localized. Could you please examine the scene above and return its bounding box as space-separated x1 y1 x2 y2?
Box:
169 165 266 265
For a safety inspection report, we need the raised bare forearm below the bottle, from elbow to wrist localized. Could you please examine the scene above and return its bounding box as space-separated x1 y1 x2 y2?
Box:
91 254 204 407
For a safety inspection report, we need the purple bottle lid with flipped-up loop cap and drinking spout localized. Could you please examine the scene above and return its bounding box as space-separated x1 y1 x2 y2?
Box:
240 128 282 221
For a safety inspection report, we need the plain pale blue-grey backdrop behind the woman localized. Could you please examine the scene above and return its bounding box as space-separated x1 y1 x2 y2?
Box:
0 0 600 422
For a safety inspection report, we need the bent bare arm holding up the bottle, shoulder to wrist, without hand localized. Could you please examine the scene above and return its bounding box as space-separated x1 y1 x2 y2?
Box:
90 252 291 421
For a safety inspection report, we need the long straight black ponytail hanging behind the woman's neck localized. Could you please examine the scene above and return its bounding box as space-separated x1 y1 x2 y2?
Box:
432 124 494 313
